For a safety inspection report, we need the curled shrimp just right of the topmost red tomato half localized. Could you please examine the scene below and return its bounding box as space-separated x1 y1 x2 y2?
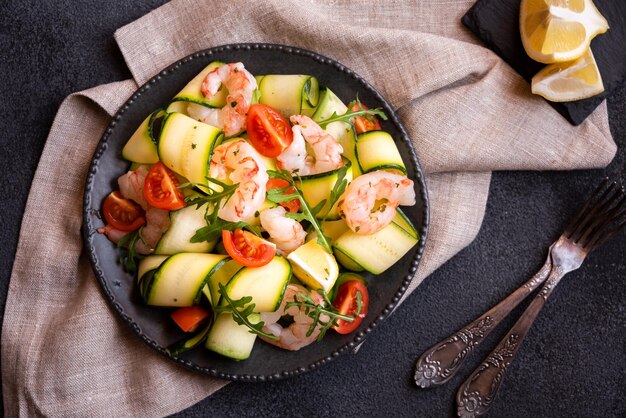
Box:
276 115 343 176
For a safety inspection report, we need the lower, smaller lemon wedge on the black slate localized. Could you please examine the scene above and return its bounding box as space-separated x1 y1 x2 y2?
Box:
532 49 604 102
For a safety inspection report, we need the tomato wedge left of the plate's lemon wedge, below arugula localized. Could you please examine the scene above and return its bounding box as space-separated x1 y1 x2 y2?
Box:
222 228 276 267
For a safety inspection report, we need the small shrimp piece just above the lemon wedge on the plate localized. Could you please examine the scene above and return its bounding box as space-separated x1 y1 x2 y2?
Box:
260 206 306 255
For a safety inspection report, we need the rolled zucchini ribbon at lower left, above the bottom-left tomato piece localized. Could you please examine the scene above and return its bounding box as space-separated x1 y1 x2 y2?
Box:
140 253 228 307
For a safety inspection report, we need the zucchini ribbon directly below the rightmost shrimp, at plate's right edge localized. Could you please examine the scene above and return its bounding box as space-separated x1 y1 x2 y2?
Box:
332 222 418 274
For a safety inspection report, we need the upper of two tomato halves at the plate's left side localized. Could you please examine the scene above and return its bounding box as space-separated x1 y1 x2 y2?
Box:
143 161 185 210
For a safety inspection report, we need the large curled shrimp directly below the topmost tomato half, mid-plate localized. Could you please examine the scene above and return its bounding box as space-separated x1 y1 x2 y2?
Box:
209 139 268 222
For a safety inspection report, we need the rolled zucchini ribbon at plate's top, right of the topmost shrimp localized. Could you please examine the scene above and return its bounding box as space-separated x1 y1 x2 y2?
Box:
259 74 319 118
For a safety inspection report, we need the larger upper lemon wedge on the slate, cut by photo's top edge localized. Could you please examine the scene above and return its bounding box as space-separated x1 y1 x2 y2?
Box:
520 0 609 64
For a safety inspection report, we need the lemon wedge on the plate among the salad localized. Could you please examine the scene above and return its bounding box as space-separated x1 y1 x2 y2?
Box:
287 239 339 292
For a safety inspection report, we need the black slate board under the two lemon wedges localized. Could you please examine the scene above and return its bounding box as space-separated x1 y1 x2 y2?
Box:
462 0 626 125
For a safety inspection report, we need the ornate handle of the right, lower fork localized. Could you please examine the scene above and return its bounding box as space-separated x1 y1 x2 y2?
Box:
456 264 565 418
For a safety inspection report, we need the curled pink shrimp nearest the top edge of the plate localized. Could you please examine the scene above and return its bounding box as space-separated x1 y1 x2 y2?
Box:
187 62 257 138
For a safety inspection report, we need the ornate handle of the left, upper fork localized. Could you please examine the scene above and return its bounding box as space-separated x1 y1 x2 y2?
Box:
415 255 552 388
